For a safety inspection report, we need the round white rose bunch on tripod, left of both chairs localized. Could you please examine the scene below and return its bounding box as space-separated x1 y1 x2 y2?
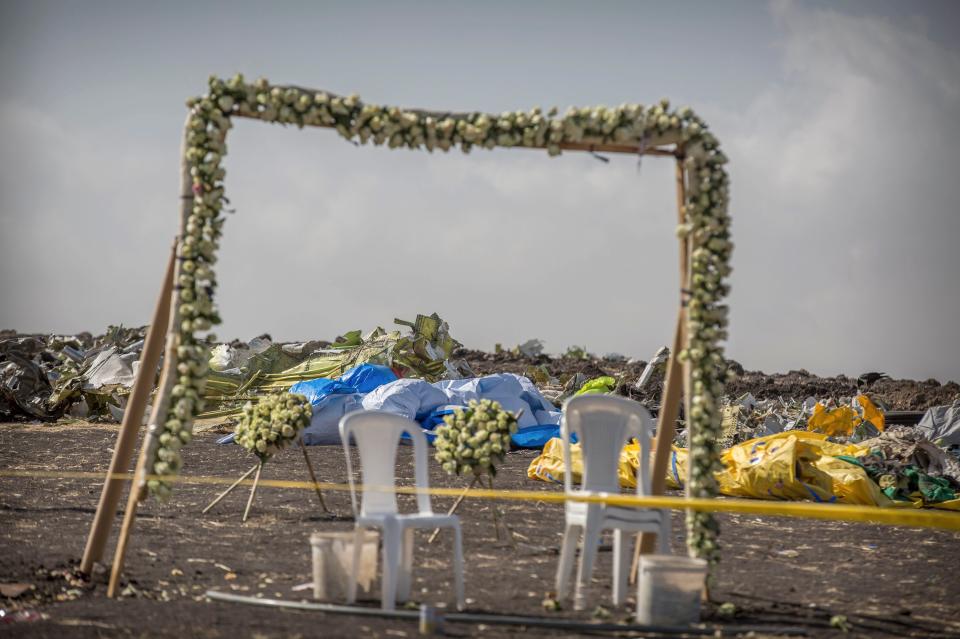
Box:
233 392 313 461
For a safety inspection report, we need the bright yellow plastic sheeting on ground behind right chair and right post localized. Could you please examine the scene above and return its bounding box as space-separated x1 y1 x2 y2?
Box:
527 431 936 510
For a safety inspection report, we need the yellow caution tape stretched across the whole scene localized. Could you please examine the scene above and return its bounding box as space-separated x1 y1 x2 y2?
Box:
0 470 960 531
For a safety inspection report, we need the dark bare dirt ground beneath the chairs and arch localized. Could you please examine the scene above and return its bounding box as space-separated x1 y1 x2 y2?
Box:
0 424 960 638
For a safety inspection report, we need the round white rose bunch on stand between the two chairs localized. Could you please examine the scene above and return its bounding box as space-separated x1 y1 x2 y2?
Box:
433 399 517 476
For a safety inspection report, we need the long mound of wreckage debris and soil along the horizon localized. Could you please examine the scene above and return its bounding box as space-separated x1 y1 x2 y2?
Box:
0 324 960 440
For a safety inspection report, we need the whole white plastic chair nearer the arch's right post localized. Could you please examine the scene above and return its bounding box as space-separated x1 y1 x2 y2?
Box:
557 395 670 610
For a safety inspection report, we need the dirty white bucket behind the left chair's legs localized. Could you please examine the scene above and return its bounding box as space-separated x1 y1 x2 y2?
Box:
310 530 380 602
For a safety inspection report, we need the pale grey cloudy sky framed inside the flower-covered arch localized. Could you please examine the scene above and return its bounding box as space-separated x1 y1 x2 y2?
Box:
212 124 676 352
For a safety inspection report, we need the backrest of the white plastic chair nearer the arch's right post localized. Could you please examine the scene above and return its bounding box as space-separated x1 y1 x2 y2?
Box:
560 395 653 495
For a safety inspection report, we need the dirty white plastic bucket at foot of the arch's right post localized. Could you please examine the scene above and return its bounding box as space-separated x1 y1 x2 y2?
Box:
636 555 707 626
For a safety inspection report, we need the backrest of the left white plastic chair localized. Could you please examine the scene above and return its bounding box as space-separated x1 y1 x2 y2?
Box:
340 410 433 517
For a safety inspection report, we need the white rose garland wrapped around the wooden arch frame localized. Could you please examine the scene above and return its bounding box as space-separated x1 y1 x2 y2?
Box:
149 75 733 559
